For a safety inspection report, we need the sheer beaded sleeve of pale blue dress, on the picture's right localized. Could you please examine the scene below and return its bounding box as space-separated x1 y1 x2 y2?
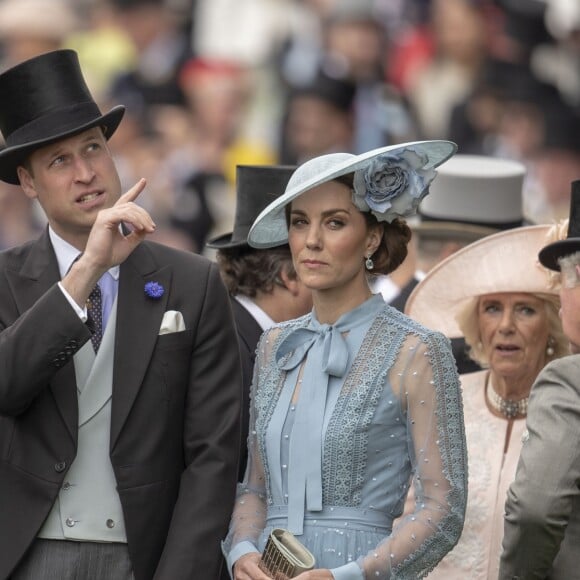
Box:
358 333 467 579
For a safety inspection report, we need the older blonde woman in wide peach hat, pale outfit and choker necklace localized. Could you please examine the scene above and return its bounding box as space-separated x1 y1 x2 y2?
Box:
405 225 568 580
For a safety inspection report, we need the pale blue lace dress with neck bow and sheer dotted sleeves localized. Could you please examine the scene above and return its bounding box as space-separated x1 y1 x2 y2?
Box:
223 296 467 580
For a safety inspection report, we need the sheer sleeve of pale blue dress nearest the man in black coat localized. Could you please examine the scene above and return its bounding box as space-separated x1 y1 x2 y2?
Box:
222 329 279 565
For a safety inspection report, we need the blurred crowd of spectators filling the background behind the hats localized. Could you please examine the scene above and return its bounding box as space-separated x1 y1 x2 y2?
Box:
0 0 580 254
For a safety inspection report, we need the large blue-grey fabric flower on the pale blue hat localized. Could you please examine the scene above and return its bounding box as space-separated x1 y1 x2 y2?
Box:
353 148 437 222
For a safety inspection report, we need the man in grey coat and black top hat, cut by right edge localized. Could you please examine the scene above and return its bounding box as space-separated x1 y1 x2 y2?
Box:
499 181 580 580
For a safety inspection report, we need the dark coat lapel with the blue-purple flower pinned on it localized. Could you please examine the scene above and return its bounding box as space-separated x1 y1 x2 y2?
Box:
111 244 171 450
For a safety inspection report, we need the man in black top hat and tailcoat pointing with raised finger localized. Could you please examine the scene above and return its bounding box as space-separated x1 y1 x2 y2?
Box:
0 50 242 580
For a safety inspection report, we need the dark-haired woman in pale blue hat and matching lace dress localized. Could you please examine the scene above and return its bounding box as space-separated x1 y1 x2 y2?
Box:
224 141 467 580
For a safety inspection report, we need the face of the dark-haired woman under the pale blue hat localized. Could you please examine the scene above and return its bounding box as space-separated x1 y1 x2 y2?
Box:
288 181 381 290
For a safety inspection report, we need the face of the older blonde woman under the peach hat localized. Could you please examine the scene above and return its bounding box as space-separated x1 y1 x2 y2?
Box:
477 292 550 386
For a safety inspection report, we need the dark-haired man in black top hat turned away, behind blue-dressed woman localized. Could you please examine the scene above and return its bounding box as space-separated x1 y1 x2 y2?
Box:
207 165 312 481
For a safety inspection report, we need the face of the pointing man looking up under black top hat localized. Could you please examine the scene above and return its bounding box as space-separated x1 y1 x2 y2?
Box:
18 127 121 248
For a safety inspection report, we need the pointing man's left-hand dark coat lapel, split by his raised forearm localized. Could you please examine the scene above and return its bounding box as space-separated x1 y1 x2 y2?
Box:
7 230 78 441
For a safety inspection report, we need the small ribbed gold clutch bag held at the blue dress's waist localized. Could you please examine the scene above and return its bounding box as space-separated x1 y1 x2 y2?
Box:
258 528 316 580
